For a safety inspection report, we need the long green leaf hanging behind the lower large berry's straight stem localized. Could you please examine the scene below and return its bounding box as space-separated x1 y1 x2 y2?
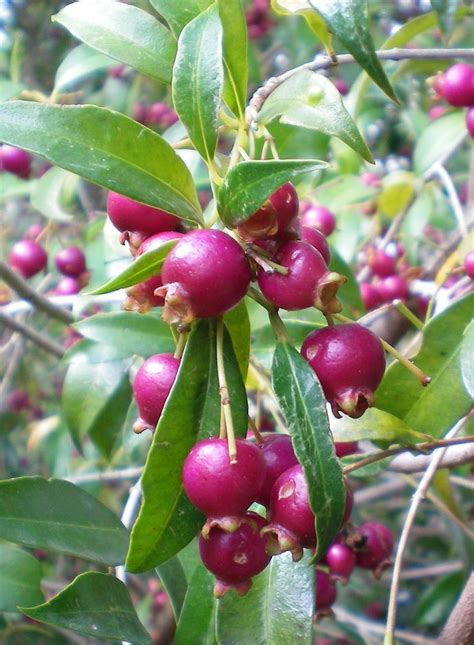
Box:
127 320 248 572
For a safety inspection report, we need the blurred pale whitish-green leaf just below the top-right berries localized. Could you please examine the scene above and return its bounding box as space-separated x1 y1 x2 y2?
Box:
413 110 467 175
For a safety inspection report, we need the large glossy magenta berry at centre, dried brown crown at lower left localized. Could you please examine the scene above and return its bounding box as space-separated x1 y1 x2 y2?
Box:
158 229 252 323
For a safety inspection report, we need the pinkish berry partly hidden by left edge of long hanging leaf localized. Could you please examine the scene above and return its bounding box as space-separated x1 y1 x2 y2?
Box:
133 354 179 432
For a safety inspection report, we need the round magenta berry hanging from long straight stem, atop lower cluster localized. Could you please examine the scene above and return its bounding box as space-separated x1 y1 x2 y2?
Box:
183 437 265 535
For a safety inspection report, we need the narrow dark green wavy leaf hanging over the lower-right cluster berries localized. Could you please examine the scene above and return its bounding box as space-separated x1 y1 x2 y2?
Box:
272 342 345 560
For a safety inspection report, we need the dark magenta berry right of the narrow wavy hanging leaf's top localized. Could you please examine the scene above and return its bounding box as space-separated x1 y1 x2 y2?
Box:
301 323 385 418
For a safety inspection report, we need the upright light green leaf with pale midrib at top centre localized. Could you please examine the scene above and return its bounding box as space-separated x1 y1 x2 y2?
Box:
173 4 224 163
